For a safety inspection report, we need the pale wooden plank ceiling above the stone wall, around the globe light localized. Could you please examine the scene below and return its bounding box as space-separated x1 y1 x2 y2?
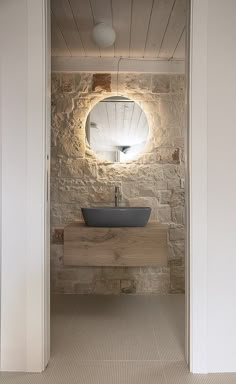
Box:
51 0 188 60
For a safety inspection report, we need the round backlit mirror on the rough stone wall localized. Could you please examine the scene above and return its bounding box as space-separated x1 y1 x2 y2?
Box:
86 96 149 163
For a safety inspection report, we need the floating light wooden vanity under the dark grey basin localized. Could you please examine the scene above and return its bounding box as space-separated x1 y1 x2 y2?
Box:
64 222 168 267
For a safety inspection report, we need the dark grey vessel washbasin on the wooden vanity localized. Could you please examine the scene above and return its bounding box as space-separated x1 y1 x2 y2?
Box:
81 207 151 227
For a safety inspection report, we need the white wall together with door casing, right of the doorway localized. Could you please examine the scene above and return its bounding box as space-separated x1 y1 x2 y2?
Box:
189 0 236 373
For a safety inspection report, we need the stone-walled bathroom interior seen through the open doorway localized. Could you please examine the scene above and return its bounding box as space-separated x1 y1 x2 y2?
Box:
50 0 187 383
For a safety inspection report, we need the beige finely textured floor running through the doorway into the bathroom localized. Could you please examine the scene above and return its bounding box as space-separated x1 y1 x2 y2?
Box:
0 295 236 384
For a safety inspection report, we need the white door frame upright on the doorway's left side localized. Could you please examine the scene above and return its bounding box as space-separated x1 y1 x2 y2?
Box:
26 0 51 371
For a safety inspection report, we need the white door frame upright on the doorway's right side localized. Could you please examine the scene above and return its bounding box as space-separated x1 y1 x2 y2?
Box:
186 0 208 373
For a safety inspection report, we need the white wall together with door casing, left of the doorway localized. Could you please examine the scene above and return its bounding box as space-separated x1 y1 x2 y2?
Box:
0 0 47 371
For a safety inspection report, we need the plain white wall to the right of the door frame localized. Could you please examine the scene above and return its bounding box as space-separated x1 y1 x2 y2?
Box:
207 0 236 372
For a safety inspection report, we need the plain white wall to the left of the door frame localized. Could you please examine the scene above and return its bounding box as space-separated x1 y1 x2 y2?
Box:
0 0 27 370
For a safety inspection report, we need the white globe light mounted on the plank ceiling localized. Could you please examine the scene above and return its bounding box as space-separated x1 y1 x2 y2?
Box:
92 23 116 48
